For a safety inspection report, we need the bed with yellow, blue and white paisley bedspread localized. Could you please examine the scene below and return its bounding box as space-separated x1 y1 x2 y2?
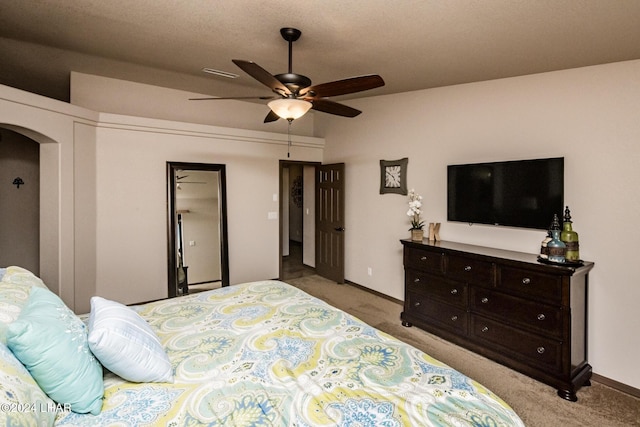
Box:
0 267 524 427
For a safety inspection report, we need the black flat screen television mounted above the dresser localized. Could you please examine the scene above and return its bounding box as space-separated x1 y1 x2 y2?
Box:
447 157 564 230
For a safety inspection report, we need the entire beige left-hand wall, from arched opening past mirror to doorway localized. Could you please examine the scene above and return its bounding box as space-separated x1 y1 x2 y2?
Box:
0 81 324 312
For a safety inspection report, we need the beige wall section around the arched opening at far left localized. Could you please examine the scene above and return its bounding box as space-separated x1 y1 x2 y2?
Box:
0 85 98 307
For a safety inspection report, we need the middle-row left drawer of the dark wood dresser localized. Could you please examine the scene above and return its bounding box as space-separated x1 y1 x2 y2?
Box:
406 270 467 307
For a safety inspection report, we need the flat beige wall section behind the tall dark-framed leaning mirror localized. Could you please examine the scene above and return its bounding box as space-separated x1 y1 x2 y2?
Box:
96 114 324 303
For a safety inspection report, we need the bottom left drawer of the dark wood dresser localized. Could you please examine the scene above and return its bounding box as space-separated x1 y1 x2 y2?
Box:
404 291 469 335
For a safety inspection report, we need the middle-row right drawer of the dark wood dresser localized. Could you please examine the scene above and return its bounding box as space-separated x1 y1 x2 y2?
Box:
470 288 563 339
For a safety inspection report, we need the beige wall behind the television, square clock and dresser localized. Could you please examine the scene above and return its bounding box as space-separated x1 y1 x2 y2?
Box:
316 61 640 388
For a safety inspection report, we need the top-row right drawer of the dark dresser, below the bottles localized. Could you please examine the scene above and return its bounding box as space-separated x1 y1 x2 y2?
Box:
498 267 562 305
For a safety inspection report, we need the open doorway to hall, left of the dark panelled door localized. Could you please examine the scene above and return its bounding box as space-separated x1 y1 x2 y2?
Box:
279 160 319 280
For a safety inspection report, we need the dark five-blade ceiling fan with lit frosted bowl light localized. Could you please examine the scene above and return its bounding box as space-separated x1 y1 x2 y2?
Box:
191 28 384 123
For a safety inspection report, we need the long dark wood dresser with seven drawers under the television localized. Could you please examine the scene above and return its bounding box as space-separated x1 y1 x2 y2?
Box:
401 240 593 401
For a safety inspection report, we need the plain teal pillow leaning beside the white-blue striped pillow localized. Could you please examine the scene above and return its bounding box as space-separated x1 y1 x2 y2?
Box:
7 287 104 415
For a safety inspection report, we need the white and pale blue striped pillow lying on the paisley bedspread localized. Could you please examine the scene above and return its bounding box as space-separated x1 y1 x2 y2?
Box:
89 297 173 382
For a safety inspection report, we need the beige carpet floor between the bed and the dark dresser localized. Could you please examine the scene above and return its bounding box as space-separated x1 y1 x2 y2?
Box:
287 276 640 427
